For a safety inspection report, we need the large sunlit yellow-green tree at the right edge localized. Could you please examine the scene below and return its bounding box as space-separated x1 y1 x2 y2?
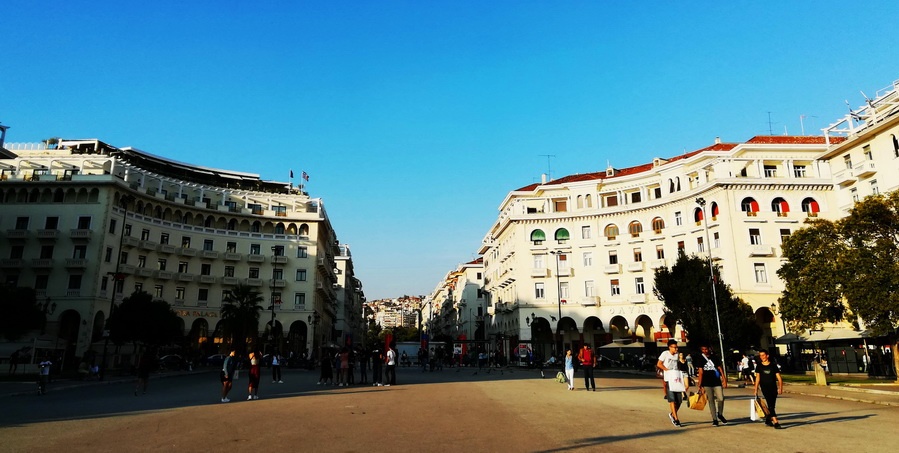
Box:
777 192 899 378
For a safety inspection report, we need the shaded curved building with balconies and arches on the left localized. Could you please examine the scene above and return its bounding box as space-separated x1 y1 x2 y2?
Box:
0 140 361 364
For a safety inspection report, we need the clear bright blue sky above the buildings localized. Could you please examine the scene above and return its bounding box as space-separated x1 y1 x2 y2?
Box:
0 0 899 300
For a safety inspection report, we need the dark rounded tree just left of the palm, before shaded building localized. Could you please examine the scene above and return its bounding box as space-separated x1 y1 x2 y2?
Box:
109 291 183 346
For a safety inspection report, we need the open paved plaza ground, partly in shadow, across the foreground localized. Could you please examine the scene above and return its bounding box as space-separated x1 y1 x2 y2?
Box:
0 368 899 453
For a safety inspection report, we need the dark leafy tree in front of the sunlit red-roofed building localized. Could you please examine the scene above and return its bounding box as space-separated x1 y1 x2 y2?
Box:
653 252 762 356
